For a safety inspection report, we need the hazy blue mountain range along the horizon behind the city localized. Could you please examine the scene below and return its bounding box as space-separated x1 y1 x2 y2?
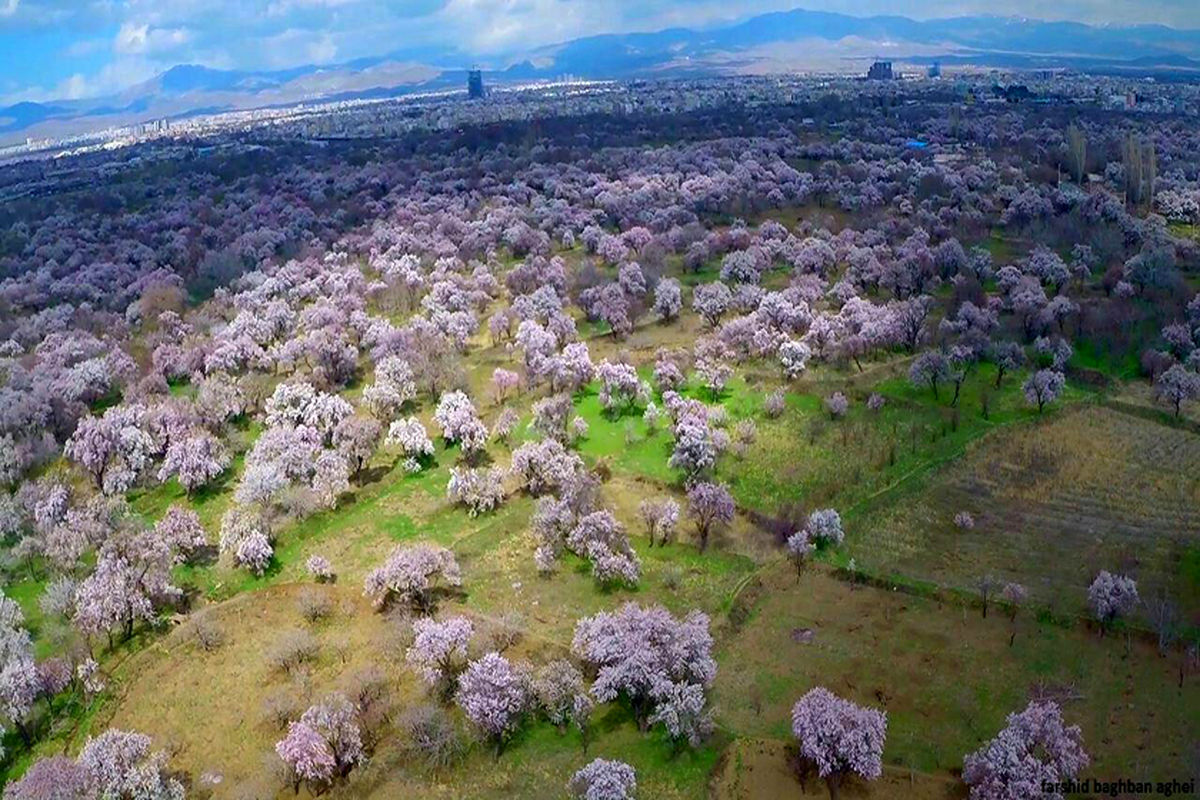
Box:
0 8 1200 144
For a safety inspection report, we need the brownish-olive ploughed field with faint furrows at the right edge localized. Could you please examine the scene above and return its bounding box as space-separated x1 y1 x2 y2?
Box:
850 405 1200 614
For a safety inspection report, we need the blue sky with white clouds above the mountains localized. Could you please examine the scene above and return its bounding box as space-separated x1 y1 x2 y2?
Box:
0 0 1200 104
